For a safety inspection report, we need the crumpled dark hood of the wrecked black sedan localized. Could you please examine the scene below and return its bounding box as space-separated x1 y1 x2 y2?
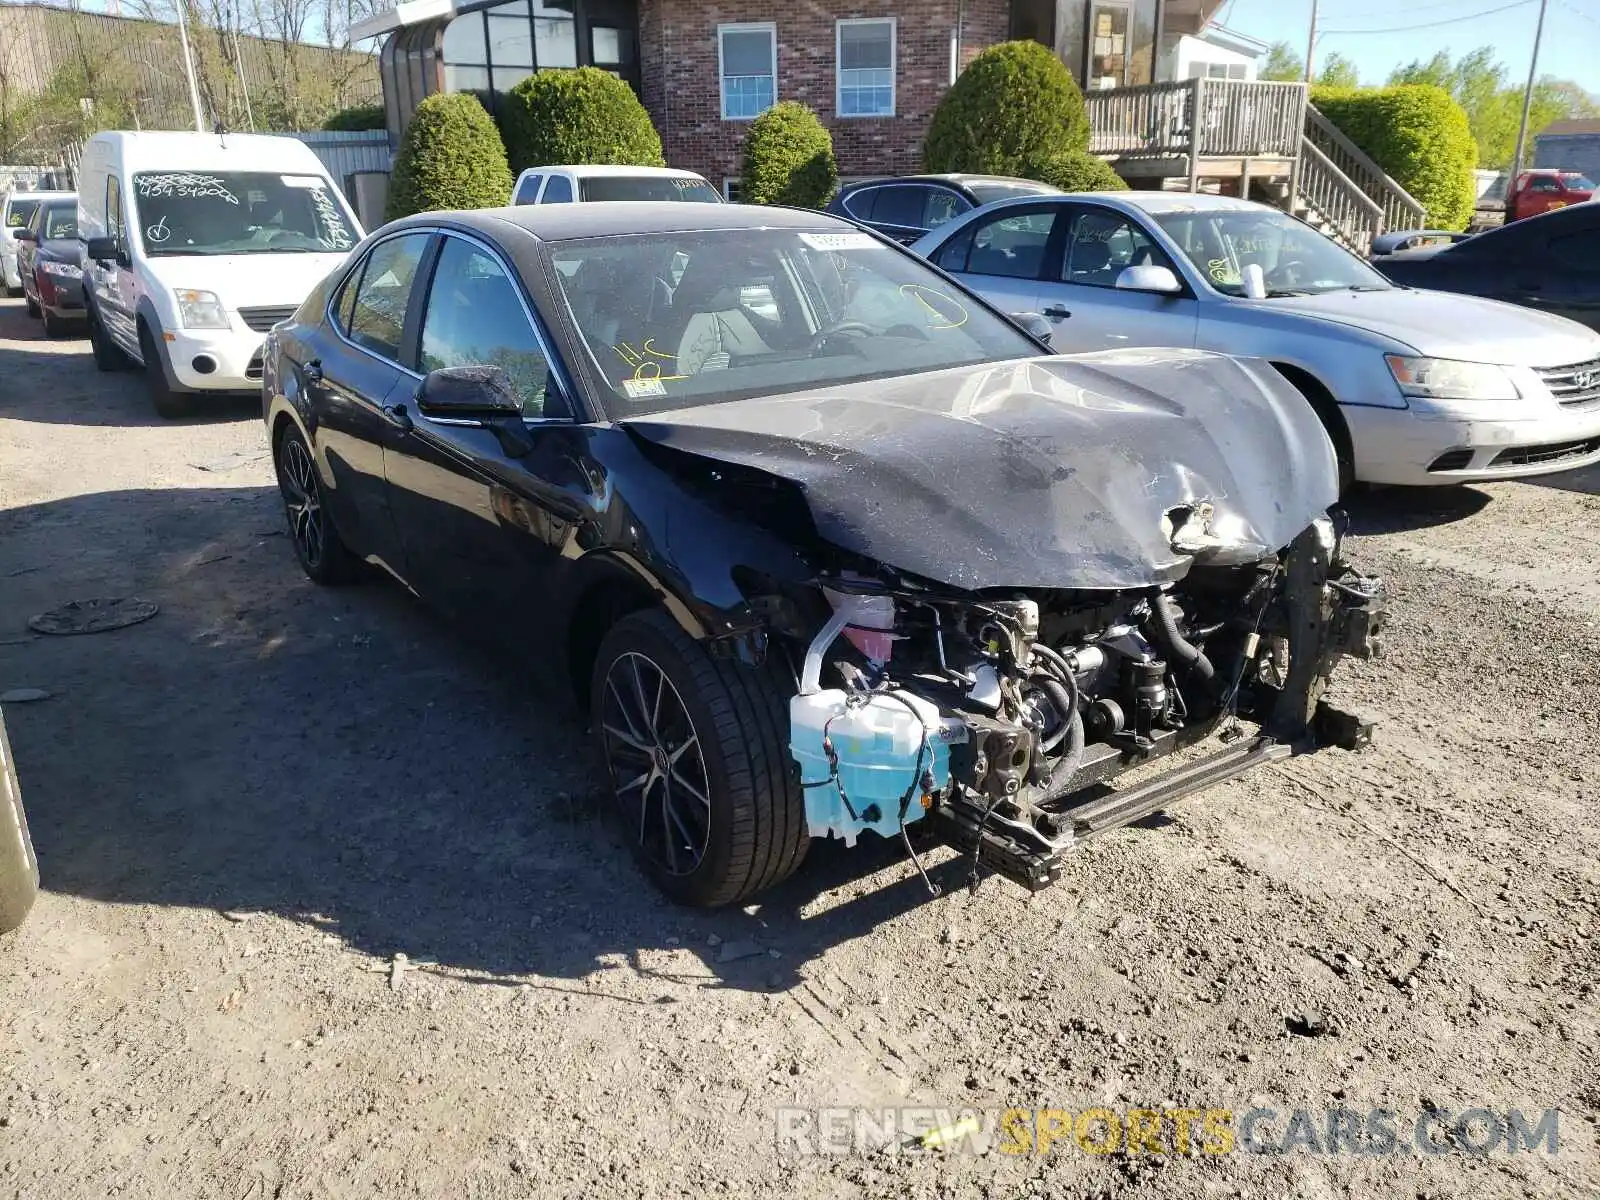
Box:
622 349 1339 589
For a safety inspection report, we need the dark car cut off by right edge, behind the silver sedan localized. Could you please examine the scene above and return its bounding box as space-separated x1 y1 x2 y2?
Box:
1374 205 1600 331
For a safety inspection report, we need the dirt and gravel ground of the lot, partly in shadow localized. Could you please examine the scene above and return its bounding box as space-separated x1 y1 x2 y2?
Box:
0 301 1600 1200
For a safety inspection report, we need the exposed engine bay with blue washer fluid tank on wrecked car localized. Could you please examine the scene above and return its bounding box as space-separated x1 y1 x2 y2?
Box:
790 506 1384 890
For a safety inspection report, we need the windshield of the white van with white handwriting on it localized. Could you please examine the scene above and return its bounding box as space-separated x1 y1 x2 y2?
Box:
133 171 357 258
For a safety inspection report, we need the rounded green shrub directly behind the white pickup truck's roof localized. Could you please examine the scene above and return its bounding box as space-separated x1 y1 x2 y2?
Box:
501 67 667 174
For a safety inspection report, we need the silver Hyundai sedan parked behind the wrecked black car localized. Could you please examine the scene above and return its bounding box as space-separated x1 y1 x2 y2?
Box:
914 192 1600 485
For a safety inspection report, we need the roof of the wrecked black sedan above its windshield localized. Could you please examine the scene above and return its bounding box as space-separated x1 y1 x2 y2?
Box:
397 200 838 242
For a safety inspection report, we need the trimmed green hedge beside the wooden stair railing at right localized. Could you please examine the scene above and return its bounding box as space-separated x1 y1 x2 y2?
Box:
1312 83 1478 229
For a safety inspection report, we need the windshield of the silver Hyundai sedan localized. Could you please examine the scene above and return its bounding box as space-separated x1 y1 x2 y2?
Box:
1150 210 1392 296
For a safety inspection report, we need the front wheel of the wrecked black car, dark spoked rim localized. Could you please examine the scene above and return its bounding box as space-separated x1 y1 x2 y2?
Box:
589 608 810 907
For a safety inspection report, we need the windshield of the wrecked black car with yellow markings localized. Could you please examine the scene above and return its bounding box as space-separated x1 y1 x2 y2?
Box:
549 229 1040 418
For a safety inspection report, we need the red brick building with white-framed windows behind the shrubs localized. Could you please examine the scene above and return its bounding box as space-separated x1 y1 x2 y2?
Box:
352 0 1221 186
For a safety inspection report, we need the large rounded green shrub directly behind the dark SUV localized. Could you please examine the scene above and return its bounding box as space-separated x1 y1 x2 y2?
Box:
922 42 1090 174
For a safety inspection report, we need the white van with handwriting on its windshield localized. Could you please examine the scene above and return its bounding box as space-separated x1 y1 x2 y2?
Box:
78 133 363 416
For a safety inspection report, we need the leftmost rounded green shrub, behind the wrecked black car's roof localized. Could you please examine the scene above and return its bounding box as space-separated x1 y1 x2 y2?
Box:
389 93 510 221
